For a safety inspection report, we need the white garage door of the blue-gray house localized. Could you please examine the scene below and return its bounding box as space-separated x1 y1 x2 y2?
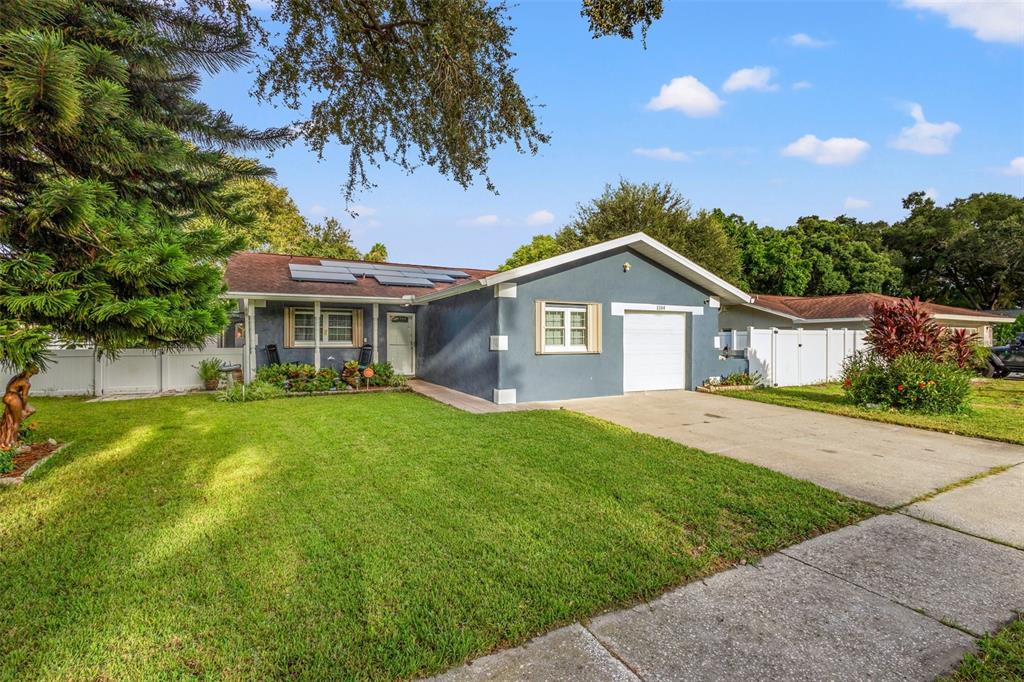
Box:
623 311 686 391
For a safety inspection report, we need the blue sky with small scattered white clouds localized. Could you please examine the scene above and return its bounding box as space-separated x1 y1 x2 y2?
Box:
201 0 1024 267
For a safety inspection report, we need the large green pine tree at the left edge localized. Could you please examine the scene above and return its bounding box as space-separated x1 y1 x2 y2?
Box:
0 0 291 447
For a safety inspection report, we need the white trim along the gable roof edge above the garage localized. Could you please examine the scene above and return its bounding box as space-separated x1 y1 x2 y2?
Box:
448 232 754 303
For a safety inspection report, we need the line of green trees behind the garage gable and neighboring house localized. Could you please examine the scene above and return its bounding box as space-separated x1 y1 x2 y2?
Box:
502 180 1024 310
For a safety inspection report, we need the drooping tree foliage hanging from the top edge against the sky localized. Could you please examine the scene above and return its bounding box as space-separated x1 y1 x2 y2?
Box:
186 0 662 199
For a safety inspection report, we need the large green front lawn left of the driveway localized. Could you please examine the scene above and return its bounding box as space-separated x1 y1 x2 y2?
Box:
0 393 873 679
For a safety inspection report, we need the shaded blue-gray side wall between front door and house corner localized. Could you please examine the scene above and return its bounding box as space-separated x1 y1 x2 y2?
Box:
416 288 501 400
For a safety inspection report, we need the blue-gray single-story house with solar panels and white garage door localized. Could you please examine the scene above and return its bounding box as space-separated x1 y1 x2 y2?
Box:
226 232 752 403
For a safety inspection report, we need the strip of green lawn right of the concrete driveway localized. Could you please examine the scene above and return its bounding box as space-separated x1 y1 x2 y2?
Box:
722 379 1024 445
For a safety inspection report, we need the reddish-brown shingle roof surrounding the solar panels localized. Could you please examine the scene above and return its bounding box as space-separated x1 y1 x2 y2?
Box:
225 252 494 298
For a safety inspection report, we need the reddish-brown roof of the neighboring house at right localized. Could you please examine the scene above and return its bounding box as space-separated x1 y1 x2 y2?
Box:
751 294 1013 323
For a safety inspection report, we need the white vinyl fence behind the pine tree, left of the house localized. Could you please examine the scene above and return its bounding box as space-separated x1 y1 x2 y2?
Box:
0 348 243 395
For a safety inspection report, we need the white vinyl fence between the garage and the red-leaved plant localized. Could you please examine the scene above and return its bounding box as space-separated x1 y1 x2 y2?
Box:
720 327 867 386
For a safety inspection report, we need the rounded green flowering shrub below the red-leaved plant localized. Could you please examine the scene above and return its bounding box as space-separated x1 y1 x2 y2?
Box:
843 353 971 414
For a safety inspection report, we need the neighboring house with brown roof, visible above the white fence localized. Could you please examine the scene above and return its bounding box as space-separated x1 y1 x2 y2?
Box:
721 294 1013 345
